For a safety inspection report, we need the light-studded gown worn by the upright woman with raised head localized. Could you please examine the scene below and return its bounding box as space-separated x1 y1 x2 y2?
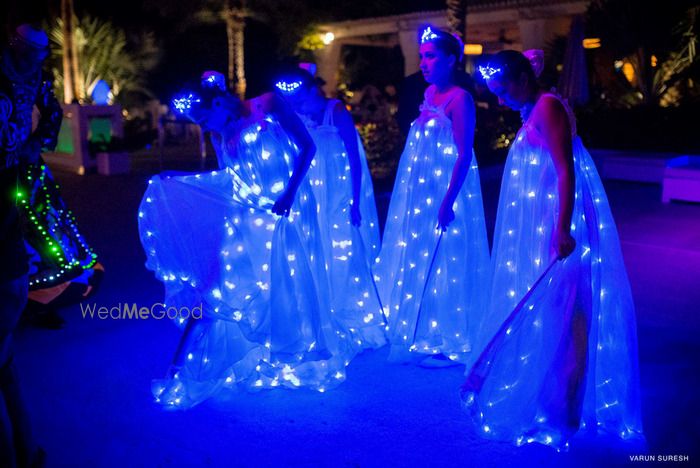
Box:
375 88 489 363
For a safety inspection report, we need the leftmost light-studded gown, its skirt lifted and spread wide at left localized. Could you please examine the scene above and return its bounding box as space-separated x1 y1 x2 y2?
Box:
139 117 356 408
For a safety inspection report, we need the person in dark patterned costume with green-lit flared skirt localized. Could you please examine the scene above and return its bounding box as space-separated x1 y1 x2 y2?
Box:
0 25 103 328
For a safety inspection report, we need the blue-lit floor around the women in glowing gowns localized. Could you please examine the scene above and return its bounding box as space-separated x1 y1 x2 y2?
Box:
12 160 700 467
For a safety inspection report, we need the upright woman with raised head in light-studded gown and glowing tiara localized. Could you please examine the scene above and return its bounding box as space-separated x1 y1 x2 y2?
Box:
375 27 489 366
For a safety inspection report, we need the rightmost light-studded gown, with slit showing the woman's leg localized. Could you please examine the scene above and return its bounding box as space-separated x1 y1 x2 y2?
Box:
462 94 642 449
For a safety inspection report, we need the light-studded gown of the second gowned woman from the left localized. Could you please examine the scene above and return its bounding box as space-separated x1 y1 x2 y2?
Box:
301 100 386 348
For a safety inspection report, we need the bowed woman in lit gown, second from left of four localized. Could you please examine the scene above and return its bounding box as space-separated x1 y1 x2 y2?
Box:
276 68 386 348
